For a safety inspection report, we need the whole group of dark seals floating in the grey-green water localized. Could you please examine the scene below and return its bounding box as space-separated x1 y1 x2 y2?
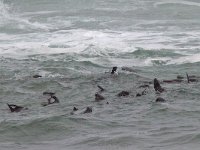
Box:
7 66 197 114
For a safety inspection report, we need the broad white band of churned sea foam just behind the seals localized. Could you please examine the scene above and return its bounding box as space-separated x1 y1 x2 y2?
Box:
0 29 200 66
